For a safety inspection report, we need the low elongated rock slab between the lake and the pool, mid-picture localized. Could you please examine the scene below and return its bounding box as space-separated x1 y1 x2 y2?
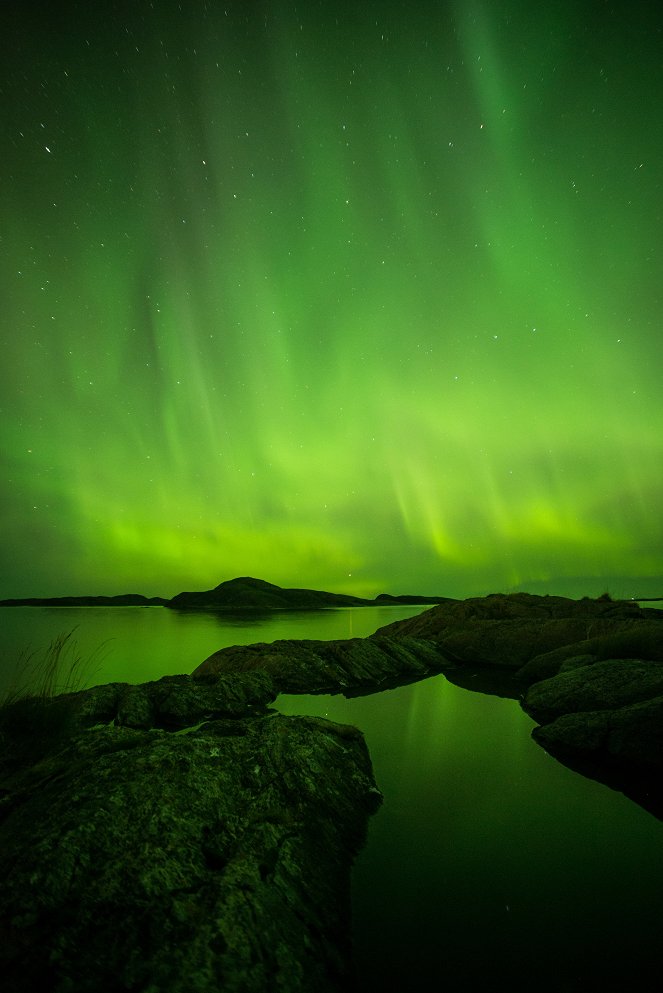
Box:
193 637 448 696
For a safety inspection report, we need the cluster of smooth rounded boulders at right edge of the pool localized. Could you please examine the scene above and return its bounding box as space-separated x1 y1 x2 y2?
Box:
506 610 663 792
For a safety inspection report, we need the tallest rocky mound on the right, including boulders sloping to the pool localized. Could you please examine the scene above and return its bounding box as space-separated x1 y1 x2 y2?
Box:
376 593 663 784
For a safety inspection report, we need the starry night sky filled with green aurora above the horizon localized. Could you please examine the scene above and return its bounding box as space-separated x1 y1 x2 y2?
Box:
0 0 663 597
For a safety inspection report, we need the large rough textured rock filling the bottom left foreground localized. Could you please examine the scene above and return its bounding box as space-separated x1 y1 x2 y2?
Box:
0 708 380 993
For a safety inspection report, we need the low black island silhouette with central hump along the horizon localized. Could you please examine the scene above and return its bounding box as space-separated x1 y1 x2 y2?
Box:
0 576 451 610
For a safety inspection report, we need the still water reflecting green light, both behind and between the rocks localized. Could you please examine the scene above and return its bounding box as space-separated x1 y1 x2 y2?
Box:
0 607 663 993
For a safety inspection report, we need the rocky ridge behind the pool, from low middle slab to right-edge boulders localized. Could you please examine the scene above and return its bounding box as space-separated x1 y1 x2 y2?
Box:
194 593 663 816
